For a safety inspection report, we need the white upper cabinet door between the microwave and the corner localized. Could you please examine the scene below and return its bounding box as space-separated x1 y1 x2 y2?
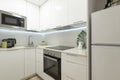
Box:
27 2 39 30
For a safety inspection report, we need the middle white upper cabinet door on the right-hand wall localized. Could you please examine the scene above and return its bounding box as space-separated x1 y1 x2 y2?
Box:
52 0 68 27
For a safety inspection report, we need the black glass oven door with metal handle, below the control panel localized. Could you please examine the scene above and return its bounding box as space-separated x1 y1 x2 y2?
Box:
44 54 61 80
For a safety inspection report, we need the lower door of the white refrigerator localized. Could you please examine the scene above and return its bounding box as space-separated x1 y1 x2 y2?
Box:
92 46 120 80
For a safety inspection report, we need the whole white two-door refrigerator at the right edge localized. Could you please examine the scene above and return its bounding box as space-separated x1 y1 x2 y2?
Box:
91 6 120 80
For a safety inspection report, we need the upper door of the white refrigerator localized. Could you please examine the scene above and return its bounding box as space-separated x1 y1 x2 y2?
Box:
91 5 120 44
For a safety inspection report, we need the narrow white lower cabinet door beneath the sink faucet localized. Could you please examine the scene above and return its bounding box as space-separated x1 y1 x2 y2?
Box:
25 49 35 77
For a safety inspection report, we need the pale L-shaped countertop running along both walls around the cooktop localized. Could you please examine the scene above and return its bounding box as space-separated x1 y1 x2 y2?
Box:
0 45 87 57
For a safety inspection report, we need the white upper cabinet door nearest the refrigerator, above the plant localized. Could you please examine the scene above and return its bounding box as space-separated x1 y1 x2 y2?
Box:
68 0 87 24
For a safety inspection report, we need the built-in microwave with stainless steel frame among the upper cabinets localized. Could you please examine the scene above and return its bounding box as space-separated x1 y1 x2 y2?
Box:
0 10 27 29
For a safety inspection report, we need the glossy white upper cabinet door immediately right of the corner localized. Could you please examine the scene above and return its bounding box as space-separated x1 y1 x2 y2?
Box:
40 0 55 30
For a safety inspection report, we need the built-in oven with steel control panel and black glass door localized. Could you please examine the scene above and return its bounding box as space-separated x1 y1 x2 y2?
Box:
44 49 61 80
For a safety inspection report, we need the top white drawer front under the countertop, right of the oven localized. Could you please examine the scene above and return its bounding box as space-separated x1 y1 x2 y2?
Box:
62 53 87 65
